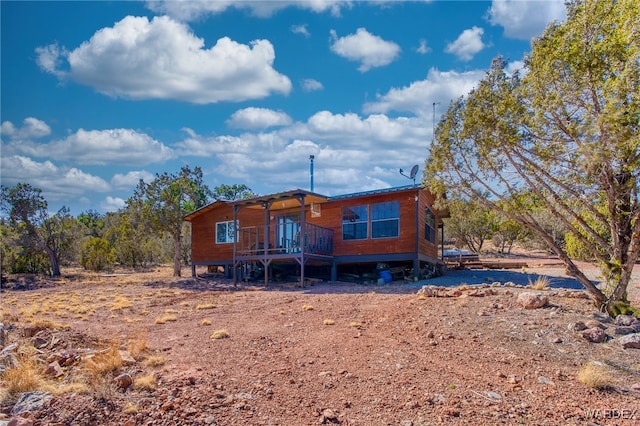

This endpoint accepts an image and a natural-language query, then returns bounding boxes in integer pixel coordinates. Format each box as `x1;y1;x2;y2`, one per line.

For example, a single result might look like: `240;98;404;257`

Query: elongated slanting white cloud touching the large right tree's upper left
363;68;486;119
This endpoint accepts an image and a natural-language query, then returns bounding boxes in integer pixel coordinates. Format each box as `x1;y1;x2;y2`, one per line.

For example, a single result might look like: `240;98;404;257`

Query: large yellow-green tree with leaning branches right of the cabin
425;0;640;315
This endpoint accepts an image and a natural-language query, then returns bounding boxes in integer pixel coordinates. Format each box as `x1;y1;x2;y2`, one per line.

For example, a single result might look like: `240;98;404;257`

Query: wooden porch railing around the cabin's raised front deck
237;222;333;256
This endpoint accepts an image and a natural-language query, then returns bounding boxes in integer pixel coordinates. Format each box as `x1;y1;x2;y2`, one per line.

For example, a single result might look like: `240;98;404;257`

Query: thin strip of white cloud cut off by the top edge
147;0;352;21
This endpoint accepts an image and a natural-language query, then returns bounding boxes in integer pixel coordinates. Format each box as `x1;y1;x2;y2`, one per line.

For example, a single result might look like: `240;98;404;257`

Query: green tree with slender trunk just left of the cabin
127;166;212;277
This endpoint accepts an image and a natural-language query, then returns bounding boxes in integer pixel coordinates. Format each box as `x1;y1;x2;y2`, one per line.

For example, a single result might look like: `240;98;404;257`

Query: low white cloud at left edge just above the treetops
2;155;110;201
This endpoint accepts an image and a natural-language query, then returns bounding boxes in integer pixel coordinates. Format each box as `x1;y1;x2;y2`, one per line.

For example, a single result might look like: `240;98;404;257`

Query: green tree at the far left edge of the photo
0;183;72;276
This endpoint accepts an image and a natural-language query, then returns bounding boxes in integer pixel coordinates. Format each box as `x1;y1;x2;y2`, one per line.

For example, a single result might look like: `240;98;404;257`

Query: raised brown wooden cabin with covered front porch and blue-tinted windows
185;186;443;285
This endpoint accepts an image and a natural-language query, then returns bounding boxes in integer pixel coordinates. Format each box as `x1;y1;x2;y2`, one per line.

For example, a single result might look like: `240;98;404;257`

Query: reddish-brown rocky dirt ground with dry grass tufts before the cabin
0;262;640;426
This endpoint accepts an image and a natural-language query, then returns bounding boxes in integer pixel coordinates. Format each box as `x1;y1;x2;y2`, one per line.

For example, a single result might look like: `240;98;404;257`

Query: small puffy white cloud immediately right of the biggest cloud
331;28;400;72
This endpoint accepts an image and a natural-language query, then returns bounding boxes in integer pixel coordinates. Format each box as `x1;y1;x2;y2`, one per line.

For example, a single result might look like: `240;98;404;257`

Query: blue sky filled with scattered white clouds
0;0;565;215
